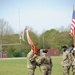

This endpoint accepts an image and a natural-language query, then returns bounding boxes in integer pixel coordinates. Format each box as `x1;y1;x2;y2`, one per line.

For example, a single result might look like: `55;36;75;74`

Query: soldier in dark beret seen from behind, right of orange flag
36;50;52;75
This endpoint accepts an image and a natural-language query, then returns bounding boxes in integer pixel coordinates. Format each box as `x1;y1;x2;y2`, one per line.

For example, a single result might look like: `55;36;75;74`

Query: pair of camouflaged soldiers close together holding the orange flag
27;49;53;75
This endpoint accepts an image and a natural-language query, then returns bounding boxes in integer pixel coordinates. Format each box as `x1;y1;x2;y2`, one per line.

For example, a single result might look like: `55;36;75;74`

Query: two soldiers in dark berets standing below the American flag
61;45;75;75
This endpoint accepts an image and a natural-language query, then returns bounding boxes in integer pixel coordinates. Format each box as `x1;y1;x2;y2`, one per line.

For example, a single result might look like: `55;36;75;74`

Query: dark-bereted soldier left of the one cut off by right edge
61;46;71;75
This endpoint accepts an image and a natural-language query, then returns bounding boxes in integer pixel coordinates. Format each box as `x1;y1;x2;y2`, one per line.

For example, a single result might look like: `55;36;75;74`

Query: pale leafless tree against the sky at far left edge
0;19;14;44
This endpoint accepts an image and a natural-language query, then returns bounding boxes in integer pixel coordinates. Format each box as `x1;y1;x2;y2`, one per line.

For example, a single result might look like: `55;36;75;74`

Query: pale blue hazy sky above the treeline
0;0;75;34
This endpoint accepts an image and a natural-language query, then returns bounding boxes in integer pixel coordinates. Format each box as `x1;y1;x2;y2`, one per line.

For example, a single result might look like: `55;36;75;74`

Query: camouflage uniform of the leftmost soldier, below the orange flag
27;51;36;75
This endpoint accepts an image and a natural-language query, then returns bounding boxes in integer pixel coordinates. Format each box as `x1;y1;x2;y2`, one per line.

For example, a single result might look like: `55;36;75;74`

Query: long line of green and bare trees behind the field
0;19;73;57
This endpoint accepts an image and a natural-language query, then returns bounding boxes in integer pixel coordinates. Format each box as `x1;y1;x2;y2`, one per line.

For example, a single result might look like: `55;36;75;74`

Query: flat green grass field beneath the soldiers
0;57;72;75
